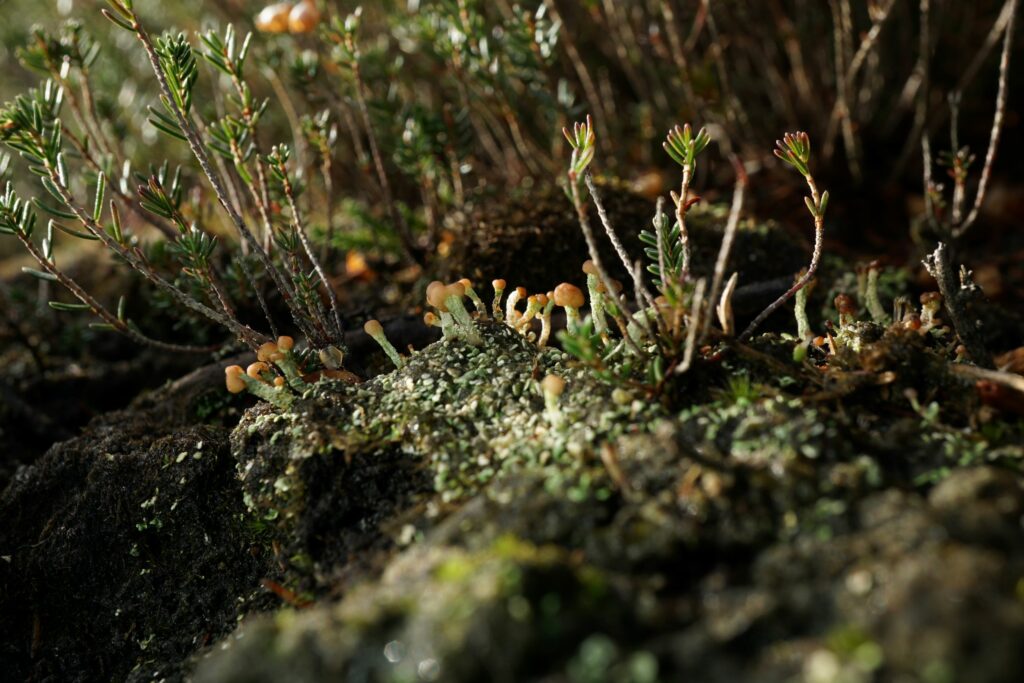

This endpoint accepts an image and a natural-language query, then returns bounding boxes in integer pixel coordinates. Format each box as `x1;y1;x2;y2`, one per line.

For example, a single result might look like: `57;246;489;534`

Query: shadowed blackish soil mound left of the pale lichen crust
0;369;271;681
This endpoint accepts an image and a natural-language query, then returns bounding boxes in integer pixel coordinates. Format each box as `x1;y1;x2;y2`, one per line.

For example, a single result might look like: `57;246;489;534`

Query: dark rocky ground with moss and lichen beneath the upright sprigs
0;194;1024;683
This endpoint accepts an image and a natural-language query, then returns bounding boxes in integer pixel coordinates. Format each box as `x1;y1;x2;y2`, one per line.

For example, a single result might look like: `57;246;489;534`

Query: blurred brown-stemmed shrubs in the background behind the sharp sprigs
0;0;1024;342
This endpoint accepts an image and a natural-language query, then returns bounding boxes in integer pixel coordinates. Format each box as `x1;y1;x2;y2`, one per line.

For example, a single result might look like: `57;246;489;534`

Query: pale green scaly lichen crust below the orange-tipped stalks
234;323;664;532
